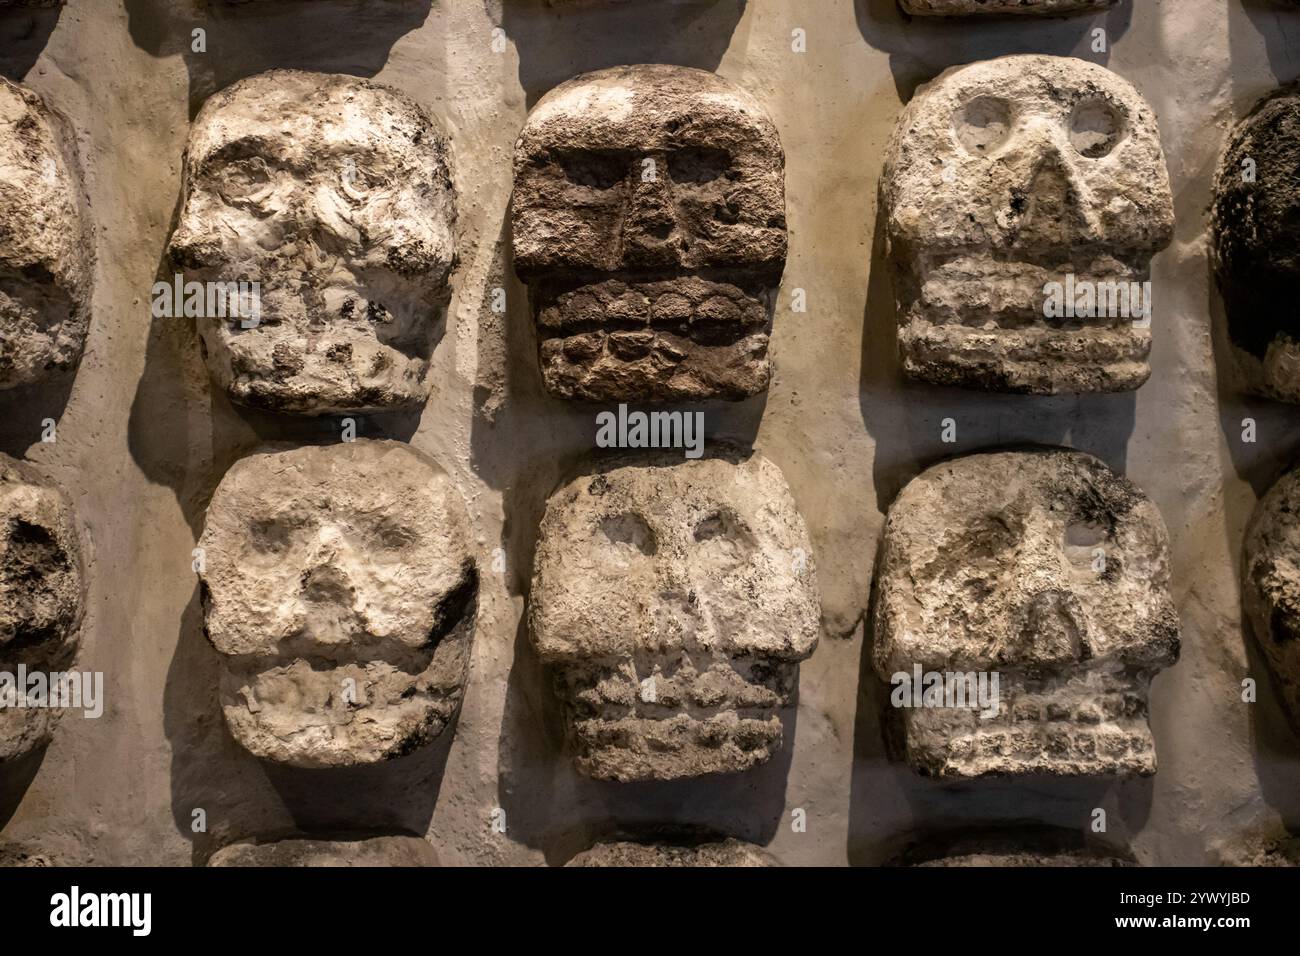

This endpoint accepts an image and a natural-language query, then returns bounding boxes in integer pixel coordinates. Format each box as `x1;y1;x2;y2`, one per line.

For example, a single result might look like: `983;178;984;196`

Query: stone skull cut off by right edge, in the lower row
1242;470;1300;734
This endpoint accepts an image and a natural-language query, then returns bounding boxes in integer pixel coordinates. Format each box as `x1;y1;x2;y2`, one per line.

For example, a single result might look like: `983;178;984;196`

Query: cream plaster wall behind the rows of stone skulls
0;0;1300;865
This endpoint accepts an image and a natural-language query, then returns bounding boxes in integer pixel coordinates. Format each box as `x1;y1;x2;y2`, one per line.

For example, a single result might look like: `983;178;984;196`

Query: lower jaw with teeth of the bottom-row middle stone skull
571;714;781;783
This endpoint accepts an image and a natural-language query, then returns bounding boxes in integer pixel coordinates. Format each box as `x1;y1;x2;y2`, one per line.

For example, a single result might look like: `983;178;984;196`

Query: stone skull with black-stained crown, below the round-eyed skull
874;449;1179;778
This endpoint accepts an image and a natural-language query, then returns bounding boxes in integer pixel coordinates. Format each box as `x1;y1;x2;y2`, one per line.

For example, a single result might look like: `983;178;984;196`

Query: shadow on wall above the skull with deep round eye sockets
854;0;1139;103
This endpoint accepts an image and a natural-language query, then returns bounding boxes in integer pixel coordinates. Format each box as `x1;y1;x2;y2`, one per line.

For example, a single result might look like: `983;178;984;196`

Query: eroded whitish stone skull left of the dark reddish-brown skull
169;70;455;415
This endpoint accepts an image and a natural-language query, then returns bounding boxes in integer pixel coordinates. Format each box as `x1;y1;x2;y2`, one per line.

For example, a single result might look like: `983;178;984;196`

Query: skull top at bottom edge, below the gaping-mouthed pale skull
208;834;438;866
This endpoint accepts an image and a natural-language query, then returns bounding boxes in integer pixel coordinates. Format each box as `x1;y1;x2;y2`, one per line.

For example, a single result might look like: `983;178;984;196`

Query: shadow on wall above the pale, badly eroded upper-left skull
125;0;433;118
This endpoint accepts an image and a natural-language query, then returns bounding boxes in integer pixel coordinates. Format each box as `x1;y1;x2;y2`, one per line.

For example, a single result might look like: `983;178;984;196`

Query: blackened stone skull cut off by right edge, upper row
1212;86;1300;402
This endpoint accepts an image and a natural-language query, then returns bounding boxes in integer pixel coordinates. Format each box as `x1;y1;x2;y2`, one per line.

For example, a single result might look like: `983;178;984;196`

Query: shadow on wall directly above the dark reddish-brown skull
485;0;745;108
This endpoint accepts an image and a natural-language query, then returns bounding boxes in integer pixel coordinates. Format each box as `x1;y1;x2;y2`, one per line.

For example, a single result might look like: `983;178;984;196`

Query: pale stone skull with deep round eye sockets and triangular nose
881;56;1174;394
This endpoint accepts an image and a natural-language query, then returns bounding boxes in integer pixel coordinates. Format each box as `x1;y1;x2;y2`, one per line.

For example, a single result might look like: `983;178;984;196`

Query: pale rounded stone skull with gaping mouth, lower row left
199;440;477;767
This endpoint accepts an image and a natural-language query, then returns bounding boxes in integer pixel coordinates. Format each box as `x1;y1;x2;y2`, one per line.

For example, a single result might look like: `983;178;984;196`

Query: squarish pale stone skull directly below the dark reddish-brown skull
529;449;820;782
